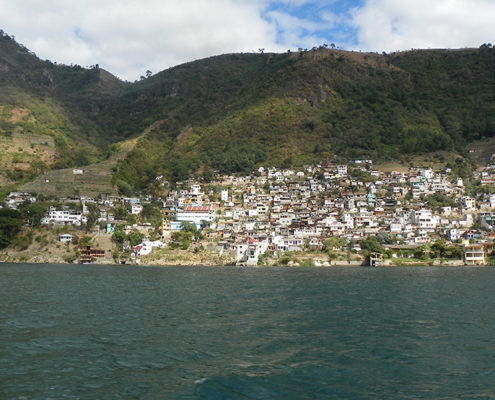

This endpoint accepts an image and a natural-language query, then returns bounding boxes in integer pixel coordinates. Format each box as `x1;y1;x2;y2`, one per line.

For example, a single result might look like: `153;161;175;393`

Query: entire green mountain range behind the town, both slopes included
0;29;495;194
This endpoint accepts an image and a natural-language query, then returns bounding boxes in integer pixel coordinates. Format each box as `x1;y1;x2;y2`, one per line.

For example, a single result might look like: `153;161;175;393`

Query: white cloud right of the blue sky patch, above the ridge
352;0;495;51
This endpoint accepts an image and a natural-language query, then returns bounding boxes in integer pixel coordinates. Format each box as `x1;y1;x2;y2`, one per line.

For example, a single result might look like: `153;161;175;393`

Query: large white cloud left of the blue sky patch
0;0;282;80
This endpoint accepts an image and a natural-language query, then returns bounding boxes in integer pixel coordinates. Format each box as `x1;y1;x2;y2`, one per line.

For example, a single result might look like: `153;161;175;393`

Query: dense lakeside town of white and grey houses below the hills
0;159;495;266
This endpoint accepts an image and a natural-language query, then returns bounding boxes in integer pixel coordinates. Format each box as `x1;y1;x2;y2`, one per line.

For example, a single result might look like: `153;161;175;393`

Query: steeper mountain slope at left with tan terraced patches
0;32;126;185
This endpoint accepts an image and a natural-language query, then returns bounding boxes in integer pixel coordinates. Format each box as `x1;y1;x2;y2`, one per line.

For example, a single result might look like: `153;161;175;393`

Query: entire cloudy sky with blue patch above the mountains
0;0;495;81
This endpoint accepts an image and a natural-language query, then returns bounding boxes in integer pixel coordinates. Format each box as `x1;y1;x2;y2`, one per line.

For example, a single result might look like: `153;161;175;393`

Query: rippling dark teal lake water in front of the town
0;264;495;400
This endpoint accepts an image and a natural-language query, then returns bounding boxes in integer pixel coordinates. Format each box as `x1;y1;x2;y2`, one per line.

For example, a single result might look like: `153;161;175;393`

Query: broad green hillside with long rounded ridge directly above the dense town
108;48;495;189
